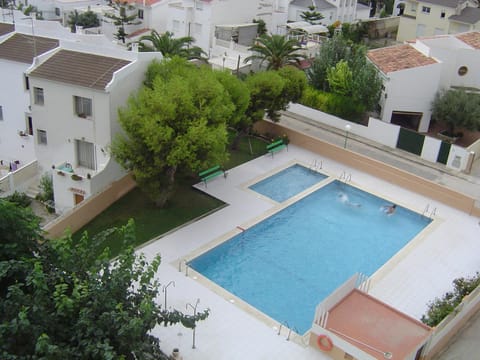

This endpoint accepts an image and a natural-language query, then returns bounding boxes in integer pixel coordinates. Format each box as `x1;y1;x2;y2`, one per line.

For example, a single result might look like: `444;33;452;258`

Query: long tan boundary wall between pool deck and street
255;121;480;216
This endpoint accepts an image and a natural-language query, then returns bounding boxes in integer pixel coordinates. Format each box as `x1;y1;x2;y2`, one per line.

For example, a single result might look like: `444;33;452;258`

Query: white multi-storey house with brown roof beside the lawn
28;42;159;213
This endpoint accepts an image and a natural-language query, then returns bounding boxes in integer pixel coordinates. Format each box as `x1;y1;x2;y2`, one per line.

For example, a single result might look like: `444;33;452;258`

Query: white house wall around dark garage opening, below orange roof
382;63;442;132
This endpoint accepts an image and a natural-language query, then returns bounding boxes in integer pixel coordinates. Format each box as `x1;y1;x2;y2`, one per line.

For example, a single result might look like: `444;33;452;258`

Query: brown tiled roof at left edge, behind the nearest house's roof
0;33;58;64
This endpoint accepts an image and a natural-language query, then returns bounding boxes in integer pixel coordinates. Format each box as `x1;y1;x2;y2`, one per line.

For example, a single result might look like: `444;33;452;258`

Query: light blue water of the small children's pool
250;164;327;202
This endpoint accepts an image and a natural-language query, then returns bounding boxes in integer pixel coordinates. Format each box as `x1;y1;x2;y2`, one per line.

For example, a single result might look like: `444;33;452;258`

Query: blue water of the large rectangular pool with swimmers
190;181;430;333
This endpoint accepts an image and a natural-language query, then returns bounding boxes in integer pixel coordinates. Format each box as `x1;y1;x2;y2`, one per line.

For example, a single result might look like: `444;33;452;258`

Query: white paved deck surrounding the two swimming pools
140;145;480;360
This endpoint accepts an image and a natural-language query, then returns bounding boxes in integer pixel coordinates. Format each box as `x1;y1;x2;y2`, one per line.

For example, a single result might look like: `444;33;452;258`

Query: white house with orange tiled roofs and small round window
367;32;480;132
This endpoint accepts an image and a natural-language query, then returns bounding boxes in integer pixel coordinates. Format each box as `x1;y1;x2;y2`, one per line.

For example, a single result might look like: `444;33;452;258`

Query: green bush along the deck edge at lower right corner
421;272;480;326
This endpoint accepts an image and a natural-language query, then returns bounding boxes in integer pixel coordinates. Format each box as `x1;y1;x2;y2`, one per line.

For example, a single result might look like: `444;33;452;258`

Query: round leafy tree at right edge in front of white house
432;89;480;136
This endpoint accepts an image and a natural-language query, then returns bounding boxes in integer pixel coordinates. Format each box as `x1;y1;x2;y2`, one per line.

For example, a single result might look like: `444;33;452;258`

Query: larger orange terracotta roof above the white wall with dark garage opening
367;44;437;74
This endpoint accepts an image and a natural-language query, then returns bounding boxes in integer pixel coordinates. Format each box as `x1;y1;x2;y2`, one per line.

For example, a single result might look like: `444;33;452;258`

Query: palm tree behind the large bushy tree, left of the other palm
138;30;206;60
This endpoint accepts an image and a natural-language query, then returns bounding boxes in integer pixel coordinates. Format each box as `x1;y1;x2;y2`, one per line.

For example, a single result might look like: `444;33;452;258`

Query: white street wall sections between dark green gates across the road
288;103;474;173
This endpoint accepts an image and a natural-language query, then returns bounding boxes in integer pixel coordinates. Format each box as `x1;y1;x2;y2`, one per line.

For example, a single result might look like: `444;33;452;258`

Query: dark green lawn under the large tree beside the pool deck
74;137;266;256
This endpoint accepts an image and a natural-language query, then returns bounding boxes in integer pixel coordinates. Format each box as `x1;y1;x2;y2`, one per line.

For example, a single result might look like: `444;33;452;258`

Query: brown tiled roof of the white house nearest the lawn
30;50;130;90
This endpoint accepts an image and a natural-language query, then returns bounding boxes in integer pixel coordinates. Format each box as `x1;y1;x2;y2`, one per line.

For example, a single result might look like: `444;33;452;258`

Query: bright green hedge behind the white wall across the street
300;87;365;122
